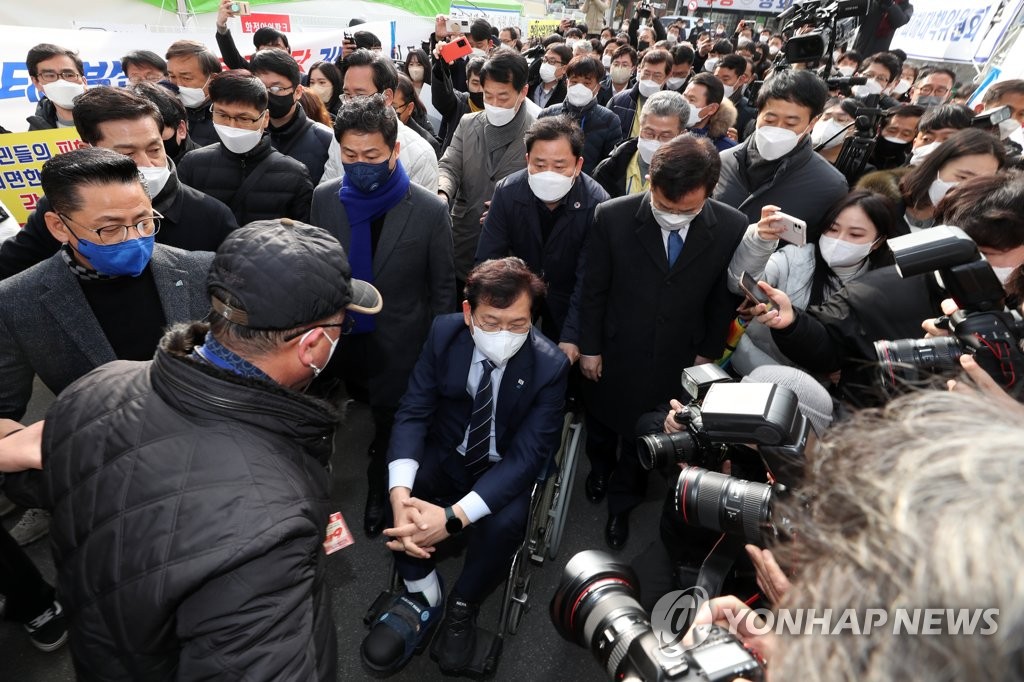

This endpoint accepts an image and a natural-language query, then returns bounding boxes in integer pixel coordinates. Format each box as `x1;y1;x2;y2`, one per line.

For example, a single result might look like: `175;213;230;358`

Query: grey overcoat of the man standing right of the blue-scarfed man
438;106;535;280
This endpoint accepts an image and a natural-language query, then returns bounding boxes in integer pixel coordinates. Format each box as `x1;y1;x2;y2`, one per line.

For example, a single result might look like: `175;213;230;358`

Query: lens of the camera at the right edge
874;336;963;391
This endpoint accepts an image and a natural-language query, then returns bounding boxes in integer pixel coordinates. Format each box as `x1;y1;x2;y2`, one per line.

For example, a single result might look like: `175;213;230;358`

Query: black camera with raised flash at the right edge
874;225;1024;399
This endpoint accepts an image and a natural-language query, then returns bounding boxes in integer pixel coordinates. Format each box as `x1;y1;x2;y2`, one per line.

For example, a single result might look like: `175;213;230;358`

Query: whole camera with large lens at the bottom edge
551;550;764;682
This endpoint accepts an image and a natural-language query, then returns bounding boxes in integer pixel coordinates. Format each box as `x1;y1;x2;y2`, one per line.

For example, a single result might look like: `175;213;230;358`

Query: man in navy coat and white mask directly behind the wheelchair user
476;117;608;363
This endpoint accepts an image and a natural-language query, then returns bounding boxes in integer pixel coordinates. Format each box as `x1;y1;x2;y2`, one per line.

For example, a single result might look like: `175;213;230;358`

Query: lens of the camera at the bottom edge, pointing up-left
551;550;650;679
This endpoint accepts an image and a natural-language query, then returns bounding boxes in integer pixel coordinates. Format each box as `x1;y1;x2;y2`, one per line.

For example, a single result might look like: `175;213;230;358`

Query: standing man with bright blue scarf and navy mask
310;95;456;538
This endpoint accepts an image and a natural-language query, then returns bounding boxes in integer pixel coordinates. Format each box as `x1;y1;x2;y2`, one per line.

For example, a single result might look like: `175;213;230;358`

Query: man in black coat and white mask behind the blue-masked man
0;86;238;280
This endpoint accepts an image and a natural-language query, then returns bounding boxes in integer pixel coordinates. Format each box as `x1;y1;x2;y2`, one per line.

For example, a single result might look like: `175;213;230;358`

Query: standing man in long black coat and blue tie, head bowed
580;135;746;549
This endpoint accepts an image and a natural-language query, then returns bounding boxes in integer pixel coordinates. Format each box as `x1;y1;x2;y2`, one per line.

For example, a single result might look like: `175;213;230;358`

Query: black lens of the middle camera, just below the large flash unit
676;467;774;547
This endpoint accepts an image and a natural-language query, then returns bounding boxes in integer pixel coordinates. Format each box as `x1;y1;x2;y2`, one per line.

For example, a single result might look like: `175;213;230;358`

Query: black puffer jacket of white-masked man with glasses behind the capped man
178;135;313;226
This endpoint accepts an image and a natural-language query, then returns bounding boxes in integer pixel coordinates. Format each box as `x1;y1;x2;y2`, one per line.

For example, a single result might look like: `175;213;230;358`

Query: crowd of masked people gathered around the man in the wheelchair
0;0;1024;680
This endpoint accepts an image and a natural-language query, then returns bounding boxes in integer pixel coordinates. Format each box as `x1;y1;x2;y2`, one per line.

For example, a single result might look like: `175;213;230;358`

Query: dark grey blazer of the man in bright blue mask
0;244;213;420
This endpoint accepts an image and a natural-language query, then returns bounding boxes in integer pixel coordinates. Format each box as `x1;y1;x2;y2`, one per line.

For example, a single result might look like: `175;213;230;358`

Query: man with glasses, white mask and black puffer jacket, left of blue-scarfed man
178;71;313;225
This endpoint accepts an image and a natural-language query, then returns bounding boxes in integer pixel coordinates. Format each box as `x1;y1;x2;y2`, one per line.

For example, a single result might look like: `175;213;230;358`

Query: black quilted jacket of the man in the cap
43;324;337;682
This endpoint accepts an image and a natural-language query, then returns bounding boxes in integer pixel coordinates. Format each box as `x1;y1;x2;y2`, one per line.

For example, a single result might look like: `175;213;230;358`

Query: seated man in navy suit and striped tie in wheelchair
361;258;569;674
